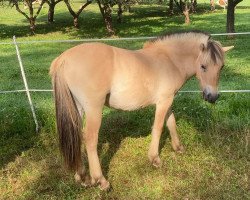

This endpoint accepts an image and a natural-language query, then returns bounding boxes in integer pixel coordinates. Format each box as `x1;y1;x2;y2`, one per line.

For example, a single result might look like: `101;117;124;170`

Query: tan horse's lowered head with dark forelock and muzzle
196;39;233;103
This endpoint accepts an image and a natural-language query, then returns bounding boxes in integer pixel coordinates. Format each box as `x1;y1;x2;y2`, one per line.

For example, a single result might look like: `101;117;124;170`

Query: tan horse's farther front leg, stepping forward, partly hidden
166;110;184;153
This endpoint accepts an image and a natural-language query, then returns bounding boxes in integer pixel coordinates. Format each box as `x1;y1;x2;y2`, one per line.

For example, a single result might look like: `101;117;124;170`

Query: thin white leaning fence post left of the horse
13;36;39;132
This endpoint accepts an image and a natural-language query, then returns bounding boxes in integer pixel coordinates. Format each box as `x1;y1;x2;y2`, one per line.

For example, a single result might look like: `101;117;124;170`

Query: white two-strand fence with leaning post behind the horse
0;32;250;132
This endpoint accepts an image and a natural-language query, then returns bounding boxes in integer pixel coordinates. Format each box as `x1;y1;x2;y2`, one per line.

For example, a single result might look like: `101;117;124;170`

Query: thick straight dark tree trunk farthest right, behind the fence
227;0;243;33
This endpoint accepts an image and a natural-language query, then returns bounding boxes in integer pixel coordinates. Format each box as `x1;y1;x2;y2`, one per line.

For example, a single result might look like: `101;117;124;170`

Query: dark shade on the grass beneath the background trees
0;6;247;39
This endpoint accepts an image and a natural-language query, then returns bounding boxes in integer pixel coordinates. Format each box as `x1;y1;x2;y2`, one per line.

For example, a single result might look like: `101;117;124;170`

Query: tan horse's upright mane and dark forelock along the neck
144;30;224;65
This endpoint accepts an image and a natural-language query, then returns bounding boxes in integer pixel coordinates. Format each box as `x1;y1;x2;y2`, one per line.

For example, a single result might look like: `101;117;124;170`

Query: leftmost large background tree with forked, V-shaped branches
10;0;45;34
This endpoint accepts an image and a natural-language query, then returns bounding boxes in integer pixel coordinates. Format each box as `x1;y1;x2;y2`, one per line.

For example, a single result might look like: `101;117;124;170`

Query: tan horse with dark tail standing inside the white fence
50;31;233;190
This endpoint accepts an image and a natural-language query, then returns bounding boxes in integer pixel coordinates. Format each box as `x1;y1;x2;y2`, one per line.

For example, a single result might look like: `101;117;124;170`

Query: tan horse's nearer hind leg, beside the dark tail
84;102;109;190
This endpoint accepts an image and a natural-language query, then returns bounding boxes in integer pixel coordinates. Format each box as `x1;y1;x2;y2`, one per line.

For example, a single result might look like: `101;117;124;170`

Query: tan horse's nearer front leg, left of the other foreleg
148;97;173;167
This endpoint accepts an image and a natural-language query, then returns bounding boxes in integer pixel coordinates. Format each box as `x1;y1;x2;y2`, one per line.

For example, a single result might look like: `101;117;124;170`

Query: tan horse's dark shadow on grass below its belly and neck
99;96;212;178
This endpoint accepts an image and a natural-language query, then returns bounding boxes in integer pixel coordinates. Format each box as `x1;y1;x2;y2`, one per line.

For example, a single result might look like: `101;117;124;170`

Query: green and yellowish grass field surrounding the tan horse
0;0;250;200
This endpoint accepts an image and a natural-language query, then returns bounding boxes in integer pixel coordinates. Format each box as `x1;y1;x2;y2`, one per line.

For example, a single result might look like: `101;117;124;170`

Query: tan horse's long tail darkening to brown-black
50;59;82;171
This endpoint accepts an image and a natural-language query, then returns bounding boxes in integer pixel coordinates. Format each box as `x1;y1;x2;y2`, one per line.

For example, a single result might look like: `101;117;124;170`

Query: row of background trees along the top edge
0;0;243;35
